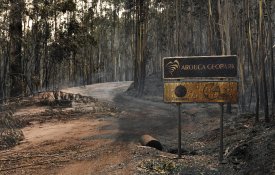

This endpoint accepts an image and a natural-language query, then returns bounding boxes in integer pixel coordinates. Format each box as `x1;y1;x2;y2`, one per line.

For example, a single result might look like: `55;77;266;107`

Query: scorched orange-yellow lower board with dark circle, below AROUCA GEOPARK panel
164;81;238;104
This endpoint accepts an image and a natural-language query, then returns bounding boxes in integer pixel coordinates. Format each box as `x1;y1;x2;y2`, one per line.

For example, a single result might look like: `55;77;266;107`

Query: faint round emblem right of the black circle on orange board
203;83;221;100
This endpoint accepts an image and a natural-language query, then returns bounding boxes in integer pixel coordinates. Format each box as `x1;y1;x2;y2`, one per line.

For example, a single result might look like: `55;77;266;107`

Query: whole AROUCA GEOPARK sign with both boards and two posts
163;55;238;162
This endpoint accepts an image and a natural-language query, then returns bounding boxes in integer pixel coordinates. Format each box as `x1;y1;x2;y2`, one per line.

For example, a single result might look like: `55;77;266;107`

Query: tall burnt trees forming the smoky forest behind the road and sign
0;0;275;122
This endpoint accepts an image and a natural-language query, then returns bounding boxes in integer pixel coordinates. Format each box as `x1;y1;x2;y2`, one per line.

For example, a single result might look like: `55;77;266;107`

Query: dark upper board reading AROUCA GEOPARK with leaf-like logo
163;55;238;79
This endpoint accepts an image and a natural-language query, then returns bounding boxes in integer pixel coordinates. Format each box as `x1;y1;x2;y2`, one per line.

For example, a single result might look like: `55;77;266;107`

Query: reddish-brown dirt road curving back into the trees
0;82;234;175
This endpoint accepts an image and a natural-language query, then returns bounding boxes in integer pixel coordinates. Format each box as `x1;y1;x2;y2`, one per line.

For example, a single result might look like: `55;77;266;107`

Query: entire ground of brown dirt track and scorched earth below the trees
0;76;275;175
